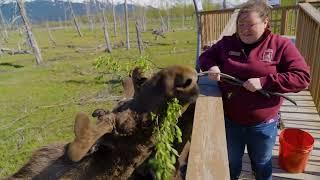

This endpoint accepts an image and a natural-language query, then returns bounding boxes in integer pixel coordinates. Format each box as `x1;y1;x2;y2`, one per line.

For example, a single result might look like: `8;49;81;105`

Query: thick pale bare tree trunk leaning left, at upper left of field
17;0;42;64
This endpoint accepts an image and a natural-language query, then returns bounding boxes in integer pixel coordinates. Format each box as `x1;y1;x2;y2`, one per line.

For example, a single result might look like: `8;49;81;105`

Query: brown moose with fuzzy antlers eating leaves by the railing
8;66;199;180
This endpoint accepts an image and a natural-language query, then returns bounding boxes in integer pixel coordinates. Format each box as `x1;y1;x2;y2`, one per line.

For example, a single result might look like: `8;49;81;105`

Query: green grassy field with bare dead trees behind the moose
0;18;196;178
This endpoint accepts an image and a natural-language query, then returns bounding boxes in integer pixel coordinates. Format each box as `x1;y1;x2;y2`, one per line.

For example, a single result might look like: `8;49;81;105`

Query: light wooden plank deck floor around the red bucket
240;91;320;180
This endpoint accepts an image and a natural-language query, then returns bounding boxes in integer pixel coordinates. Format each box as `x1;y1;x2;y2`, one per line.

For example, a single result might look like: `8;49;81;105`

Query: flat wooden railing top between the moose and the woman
186;77;230;180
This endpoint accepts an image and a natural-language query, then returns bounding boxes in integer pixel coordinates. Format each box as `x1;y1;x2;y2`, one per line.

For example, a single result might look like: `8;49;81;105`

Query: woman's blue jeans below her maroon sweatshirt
225;117;279;180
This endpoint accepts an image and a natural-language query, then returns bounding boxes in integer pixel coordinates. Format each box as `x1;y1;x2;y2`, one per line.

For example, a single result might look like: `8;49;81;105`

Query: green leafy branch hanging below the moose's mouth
149;98;182;180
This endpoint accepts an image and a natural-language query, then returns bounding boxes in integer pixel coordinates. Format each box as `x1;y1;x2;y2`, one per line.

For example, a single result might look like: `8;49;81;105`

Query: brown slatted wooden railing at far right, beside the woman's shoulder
296;3;320;112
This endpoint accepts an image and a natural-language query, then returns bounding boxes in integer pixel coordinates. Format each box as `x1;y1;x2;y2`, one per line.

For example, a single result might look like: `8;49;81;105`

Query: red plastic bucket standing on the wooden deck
279;128;314;173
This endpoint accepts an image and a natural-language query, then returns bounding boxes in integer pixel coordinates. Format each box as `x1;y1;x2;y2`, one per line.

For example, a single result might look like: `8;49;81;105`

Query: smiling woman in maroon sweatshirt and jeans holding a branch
199;1;310;180
